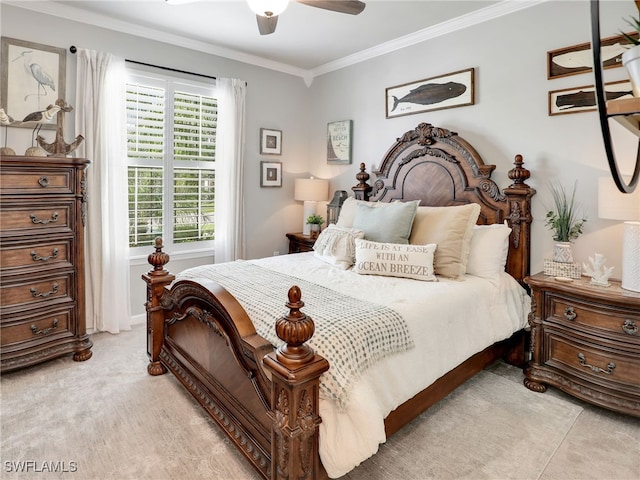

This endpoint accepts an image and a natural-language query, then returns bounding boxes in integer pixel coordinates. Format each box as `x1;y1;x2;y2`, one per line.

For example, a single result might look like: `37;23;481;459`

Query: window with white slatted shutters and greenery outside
126;72;217;254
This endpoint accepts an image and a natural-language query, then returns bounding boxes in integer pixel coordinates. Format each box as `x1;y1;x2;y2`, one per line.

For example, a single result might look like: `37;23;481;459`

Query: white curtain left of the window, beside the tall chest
75;49;131;333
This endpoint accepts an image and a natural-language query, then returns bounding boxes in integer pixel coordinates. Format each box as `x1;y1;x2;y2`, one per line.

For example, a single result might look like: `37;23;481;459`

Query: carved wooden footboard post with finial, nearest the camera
263;286;329;480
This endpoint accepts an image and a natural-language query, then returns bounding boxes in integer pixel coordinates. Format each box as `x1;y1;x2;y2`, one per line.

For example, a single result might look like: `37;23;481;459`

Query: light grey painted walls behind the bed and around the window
0;1;635;322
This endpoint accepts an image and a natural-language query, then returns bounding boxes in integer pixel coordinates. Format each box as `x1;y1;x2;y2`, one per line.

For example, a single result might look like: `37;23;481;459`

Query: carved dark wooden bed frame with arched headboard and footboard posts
143;123;535;479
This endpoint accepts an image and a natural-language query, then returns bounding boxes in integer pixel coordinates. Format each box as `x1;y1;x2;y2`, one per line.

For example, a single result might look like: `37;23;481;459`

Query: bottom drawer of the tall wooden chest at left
0;307;73;350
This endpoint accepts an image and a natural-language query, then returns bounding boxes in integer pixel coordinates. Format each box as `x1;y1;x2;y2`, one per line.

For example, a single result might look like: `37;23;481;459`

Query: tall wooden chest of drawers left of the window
0;156;92;371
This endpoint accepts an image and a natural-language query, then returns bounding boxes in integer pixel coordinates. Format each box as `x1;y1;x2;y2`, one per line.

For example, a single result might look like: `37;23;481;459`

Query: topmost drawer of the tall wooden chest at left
0;169;74;195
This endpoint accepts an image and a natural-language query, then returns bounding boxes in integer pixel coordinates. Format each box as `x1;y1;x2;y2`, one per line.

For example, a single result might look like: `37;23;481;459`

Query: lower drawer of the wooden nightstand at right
544;331;640;392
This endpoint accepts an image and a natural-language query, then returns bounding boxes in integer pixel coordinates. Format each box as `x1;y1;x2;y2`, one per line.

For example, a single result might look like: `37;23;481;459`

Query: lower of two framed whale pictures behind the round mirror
549;80;633;116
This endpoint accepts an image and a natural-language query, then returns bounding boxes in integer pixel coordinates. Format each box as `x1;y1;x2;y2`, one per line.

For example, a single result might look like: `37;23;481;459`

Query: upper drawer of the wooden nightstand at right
546;295;640;345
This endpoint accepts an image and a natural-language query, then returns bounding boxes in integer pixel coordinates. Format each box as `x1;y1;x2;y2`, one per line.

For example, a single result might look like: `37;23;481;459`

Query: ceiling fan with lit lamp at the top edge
165;0;366;35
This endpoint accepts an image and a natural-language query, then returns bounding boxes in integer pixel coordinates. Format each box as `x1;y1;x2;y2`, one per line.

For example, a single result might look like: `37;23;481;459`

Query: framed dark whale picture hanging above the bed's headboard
385;68;474;118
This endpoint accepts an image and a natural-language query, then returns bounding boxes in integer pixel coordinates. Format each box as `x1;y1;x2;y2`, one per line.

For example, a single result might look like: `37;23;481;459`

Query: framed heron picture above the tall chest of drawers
1;37;67;129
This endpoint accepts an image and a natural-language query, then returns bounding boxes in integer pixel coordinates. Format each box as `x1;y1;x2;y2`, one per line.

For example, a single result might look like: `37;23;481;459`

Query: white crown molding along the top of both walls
2;0;550;86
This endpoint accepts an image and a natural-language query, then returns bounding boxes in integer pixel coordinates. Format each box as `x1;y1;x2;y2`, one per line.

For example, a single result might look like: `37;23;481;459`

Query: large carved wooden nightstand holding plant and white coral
524;273;640;416
